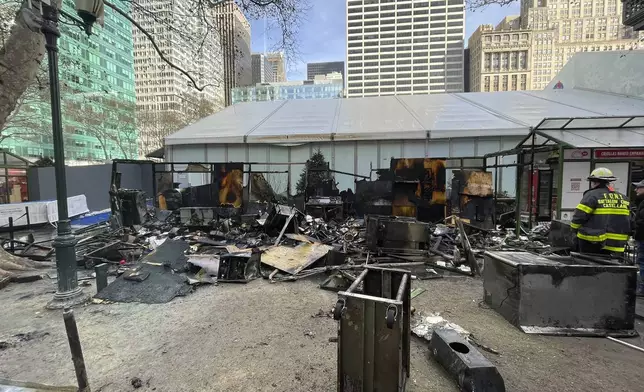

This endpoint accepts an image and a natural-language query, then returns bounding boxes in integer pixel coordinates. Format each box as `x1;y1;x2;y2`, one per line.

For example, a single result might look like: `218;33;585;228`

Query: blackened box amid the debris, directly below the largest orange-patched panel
367;216;429;251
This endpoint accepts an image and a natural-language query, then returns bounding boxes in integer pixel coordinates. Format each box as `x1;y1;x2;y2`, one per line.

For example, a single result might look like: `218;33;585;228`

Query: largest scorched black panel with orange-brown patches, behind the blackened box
391;158;446;221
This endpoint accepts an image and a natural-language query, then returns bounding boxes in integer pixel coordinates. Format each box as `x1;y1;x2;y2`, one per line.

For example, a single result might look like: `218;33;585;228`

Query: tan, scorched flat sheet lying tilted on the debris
262;243;333;275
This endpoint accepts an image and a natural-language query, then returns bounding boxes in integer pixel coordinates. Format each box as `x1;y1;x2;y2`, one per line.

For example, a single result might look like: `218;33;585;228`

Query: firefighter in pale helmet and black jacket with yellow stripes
570;167;631;255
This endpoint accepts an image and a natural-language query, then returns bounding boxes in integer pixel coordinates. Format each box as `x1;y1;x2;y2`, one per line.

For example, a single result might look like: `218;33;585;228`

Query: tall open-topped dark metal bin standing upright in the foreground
333;267;411;392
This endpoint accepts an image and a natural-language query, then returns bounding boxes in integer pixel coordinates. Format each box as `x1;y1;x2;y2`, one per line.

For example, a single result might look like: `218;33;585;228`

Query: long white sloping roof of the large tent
166;89;644;145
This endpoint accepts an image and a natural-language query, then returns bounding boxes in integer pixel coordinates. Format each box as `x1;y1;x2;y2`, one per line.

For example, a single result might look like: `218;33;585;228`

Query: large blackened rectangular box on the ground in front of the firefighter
483;252;637;336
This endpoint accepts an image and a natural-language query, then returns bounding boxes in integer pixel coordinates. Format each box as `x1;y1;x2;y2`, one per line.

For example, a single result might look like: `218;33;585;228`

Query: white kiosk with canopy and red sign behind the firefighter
485;116;644;234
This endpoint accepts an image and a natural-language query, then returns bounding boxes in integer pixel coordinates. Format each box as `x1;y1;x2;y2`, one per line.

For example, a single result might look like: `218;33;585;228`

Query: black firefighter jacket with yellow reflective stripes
570;186;631;253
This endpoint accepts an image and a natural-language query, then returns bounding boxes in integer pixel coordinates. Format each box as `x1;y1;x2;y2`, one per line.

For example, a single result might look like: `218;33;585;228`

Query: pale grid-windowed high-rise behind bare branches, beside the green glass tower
133;0;224;153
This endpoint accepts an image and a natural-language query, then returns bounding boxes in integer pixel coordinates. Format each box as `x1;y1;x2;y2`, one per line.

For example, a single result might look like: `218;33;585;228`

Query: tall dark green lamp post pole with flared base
41;3;89;309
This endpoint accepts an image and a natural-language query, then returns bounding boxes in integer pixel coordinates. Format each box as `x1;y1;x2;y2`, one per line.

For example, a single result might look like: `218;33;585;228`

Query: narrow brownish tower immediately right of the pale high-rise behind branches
213;0;253;106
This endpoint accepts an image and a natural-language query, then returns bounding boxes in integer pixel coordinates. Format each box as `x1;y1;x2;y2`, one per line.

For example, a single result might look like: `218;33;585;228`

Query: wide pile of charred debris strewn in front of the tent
77;198;548;303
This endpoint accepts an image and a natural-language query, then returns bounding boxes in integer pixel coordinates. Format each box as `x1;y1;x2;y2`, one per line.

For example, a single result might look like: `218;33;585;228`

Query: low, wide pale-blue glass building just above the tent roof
232;72;344;104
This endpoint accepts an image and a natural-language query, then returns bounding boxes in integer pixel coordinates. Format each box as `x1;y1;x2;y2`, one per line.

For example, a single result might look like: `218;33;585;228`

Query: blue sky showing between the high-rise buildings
251;0;519;80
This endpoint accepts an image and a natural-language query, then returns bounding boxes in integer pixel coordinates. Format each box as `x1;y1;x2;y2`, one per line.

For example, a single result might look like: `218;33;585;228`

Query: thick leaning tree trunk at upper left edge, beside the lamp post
0;5;45;129
